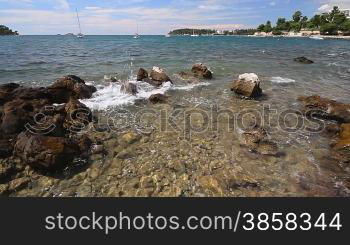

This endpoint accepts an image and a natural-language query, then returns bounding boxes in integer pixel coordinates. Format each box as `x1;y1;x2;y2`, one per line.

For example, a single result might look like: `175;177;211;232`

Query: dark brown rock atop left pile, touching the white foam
48;75;97;104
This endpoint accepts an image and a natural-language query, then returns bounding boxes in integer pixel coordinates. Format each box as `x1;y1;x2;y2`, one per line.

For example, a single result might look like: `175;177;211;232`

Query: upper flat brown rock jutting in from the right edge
298;95;350;123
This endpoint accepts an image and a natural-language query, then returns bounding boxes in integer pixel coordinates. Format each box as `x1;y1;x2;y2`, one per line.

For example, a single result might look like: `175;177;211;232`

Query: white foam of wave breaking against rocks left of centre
81;77;209;110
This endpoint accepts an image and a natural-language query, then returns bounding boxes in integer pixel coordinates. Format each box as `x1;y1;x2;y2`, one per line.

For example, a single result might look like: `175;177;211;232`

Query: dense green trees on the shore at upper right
257;6;350;35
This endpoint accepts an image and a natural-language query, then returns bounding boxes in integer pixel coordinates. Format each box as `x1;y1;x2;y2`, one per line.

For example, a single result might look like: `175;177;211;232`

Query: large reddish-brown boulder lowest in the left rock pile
14;132;81;170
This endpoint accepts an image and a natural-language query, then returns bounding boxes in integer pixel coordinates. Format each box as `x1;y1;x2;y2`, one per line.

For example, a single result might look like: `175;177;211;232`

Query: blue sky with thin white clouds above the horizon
0;0;350;35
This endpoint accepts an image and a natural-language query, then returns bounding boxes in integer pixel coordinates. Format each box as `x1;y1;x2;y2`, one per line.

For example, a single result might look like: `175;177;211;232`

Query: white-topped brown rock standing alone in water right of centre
231;73;262;98
